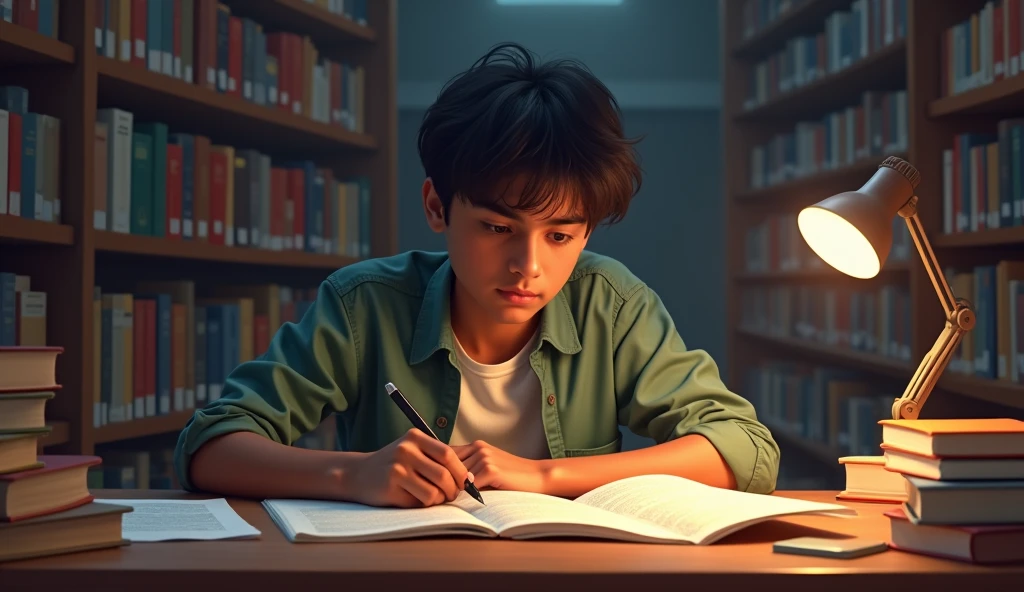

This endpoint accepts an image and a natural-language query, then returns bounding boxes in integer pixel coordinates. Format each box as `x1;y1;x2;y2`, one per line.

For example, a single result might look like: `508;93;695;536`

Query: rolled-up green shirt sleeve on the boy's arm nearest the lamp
614;286;779;494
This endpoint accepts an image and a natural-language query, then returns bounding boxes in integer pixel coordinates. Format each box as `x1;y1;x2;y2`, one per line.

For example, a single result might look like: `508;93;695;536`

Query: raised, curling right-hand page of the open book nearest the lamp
573;475;856;545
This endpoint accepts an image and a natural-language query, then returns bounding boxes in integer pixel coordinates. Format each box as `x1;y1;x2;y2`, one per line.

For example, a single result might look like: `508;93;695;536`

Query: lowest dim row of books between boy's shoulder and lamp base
743;361;900;455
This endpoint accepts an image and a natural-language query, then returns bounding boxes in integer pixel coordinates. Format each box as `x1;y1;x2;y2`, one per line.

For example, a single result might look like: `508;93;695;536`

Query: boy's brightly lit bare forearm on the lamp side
540;434;736;498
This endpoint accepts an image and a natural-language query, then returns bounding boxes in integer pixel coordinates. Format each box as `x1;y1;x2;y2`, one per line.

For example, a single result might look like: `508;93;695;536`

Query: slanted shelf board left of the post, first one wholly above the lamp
734;39;906;121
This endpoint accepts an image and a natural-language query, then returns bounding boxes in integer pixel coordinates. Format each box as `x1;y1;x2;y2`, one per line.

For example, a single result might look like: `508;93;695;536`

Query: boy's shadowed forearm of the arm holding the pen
188;431;362;500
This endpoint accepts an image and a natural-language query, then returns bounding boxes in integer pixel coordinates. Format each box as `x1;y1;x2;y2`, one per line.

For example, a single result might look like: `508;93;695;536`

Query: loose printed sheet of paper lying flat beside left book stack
95;498;260;543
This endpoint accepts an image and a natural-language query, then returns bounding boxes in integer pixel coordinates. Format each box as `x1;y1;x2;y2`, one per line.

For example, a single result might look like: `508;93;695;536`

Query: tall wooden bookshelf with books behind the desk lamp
720;0;1024;487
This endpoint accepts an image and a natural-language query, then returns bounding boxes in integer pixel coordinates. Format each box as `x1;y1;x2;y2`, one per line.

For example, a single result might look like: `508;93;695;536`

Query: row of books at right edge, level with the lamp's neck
942;118;1024;235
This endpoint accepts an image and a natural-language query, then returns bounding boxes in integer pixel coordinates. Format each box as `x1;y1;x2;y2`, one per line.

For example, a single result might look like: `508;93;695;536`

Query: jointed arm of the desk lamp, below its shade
892;204;975;419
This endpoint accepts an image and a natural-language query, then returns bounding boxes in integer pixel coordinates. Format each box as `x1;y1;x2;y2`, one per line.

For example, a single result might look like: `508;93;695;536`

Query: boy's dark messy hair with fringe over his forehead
419;43;642;234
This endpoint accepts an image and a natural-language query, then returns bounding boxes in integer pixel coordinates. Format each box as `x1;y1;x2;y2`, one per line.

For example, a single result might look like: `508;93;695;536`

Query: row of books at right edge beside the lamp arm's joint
944;260;1024;384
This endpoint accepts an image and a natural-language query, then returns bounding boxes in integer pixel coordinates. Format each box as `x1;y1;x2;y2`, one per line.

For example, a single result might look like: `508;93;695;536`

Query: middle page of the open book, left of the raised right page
451;491;683;542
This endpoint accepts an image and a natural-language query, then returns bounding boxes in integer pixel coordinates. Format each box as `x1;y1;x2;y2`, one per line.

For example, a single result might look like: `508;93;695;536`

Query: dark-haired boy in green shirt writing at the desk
175;44;779;507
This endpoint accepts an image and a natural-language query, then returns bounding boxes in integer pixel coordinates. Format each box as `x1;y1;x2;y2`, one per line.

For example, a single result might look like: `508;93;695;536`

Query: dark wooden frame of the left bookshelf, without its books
0;0;397;479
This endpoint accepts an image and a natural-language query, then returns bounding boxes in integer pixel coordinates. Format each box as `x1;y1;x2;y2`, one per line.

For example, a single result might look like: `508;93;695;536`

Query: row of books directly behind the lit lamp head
743;210;913;273
